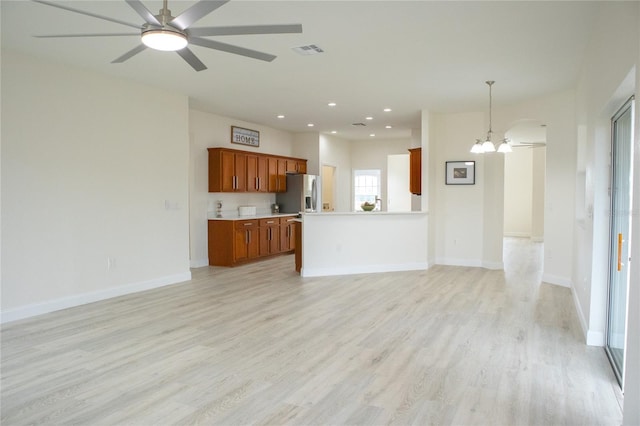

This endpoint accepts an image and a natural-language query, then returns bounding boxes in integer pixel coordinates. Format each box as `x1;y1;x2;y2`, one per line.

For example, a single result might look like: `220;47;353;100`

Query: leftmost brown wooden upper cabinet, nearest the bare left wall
208;148;247;192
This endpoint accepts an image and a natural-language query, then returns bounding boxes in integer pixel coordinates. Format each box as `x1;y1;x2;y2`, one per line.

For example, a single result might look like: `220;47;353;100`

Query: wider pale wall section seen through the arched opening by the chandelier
504;148;533;237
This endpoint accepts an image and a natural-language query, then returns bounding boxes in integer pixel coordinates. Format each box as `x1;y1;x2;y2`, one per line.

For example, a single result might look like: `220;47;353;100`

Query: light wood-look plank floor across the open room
1;239;622;425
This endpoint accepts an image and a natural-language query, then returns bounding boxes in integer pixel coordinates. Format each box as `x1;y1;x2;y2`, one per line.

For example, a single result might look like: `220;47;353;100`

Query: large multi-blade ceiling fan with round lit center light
33;0;302;71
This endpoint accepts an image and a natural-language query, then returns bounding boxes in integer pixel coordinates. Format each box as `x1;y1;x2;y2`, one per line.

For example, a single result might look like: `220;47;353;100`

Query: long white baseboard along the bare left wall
0;271;191;323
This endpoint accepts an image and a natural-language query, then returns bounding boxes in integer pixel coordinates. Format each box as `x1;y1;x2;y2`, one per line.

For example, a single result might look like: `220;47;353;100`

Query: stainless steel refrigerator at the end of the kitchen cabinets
276;175;322;213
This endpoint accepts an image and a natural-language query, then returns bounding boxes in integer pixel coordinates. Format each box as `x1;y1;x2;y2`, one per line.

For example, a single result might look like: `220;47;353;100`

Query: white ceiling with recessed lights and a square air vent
0;0;606;139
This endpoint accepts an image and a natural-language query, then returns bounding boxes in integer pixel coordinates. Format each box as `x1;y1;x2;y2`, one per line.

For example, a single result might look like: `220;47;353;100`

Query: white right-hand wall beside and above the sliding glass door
573;3;640;345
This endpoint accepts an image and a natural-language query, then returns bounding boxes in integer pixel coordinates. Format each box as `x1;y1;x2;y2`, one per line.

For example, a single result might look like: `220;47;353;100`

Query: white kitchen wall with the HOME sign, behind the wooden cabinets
189;109;296;267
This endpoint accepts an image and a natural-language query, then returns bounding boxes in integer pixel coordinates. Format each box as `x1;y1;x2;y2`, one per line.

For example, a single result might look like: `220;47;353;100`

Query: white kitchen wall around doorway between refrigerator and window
319;135;352;212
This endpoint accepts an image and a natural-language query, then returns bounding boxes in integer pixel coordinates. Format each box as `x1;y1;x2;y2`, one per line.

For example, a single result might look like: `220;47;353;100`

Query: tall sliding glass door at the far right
606;98;634;386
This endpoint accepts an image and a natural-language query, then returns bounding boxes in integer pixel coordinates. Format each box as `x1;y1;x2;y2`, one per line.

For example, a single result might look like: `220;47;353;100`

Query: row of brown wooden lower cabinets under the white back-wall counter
208;216;295;266
